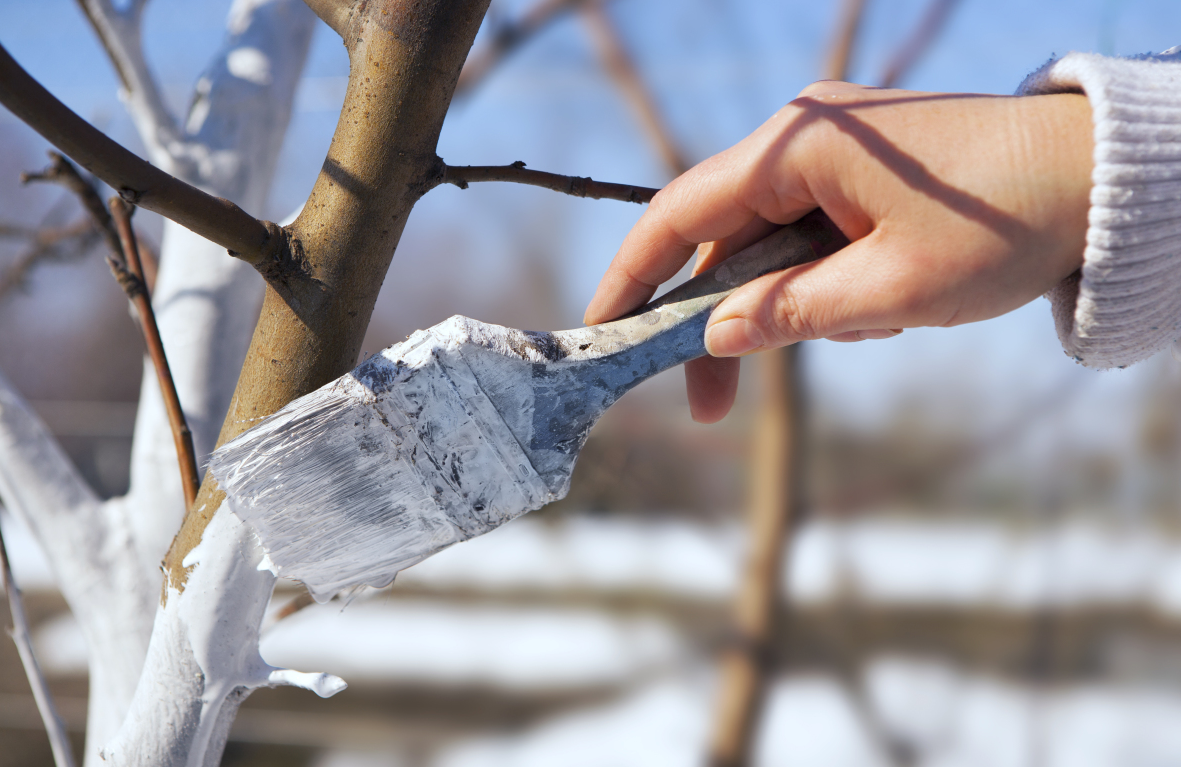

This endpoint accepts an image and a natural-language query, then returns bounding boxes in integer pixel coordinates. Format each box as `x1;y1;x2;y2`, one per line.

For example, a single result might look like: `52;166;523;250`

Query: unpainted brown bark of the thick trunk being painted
165;0;488;589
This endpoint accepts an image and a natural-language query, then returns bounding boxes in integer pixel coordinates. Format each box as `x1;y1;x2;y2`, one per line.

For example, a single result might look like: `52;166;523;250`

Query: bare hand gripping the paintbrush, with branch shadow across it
585;82;1094;423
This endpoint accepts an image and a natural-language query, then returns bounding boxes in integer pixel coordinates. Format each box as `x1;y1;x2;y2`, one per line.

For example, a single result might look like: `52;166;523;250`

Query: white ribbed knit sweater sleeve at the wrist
1017;46;1181;368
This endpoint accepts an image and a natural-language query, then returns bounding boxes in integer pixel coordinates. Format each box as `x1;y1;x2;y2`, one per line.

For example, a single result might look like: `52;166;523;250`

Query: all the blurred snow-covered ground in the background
13;503;1181;767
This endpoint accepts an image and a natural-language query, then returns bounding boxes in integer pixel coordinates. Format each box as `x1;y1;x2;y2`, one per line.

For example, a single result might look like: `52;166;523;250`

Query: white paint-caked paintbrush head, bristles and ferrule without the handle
210;324;554;600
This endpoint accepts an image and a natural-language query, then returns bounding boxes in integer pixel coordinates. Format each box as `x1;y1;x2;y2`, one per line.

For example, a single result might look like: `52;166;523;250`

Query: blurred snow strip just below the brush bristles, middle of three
262;600;684;689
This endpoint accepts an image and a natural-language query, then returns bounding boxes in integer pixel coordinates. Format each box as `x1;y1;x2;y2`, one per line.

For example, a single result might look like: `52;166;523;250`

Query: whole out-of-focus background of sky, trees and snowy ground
0;0;1181;767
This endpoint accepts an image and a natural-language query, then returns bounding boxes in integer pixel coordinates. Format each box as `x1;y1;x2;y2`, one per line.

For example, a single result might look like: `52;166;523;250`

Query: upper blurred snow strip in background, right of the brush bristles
398;514;1181;615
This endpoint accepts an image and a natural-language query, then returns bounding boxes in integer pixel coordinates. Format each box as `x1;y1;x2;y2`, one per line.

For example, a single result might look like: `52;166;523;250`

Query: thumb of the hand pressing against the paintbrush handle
705;229;955;357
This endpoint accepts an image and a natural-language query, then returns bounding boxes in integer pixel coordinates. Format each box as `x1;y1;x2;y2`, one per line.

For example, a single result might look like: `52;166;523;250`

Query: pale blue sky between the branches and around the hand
0;0;1181;451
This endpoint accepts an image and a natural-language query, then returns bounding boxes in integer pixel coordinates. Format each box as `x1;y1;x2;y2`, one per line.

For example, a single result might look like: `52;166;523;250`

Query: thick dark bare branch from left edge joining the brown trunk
0;46;275;267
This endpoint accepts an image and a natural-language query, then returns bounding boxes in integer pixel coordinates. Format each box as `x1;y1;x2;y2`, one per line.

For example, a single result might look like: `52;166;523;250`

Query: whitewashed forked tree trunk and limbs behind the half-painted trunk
0;0;315;765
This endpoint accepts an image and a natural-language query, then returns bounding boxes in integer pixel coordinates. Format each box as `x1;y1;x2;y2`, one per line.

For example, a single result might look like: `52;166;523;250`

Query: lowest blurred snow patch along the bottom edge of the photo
433;658;1181;767
